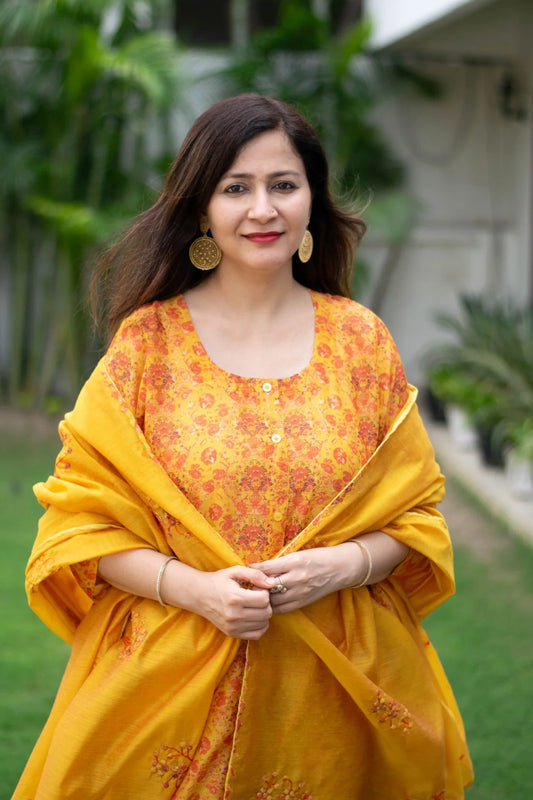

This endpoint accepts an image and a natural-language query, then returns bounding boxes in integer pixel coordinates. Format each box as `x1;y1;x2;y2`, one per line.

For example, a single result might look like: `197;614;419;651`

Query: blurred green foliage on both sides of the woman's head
0;0;414;408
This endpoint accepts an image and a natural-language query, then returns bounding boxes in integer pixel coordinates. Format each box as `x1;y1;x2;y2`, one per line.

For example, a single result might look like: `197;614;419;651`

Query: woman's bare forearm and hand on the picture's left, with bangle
98;548;276;639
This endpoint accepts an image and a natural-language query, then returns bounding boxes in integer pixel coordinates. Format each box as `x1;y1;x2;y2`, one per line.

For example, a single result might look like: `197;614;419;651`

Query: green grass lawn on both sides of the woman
0;434;533;800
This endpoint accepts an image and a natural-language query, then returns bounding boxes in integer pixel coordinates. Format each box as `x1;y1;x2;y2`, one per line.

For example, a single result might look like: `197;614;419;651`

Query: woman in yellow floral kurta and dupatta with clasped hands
15;95;471;800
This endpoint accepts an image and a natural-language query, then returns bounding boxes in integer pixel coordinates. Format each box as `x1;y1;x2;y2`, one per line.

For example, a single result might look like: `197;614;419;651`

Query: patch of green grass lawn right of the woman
426;522;533;800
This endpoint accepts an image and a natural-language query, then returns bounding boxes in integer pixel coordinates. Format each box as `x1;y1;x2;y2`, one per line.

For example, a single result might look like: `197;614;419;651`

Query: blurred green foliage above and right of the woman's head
220;0;416;302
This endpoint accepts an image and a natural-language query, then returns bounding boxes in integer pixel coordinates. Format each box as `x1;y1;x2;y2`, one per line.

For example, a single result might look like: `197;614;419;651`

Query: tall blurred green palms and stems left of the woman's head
0;0;180;407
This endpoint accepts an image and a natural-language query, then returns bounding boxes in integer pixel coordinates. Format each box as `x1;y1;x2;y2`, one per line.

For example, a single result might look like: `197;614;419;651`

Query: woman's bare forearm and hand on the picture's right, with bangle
252;531;409;614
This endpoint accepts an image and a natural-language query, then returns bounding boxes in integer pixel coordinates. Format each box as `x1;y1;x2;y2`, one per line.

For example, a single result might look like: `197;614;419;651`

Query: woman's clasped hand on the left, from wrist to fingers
189;566;276;639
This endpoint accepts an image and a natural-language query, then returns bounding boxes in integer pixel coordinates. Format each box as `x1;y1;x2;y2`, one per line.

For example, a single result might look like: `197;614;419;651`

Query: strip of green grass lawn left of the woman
0;433;69;800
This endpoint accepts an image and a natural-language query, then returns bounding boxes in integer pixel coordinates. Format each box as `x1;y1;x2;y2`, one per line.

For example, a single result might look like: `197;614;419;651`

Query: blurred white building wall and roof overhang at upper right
363;0;533;382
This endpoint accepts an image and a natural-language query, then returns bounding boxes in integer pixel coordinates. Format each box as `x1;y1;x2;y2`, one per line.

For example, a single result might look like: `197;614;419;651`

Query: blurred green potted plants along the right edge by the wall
427;296;533;500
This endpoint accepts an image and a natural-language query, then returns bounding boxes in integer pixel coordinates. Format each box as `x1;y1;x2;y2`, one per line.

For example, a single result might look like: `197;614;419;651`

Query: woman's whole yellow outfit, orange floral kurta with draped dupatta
14;294;471;800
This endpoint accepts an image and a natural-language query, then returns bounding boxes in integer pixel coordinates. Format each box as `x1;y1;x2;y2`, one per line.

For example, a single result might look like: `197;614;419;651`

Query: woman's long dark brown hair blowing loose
91;94;365;334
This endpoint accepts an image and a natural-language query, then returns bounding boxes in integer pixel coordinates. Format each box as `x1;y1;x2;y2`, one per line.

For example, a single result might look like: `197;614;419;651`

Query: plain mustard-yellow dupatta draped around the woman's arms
14;362;471;800
